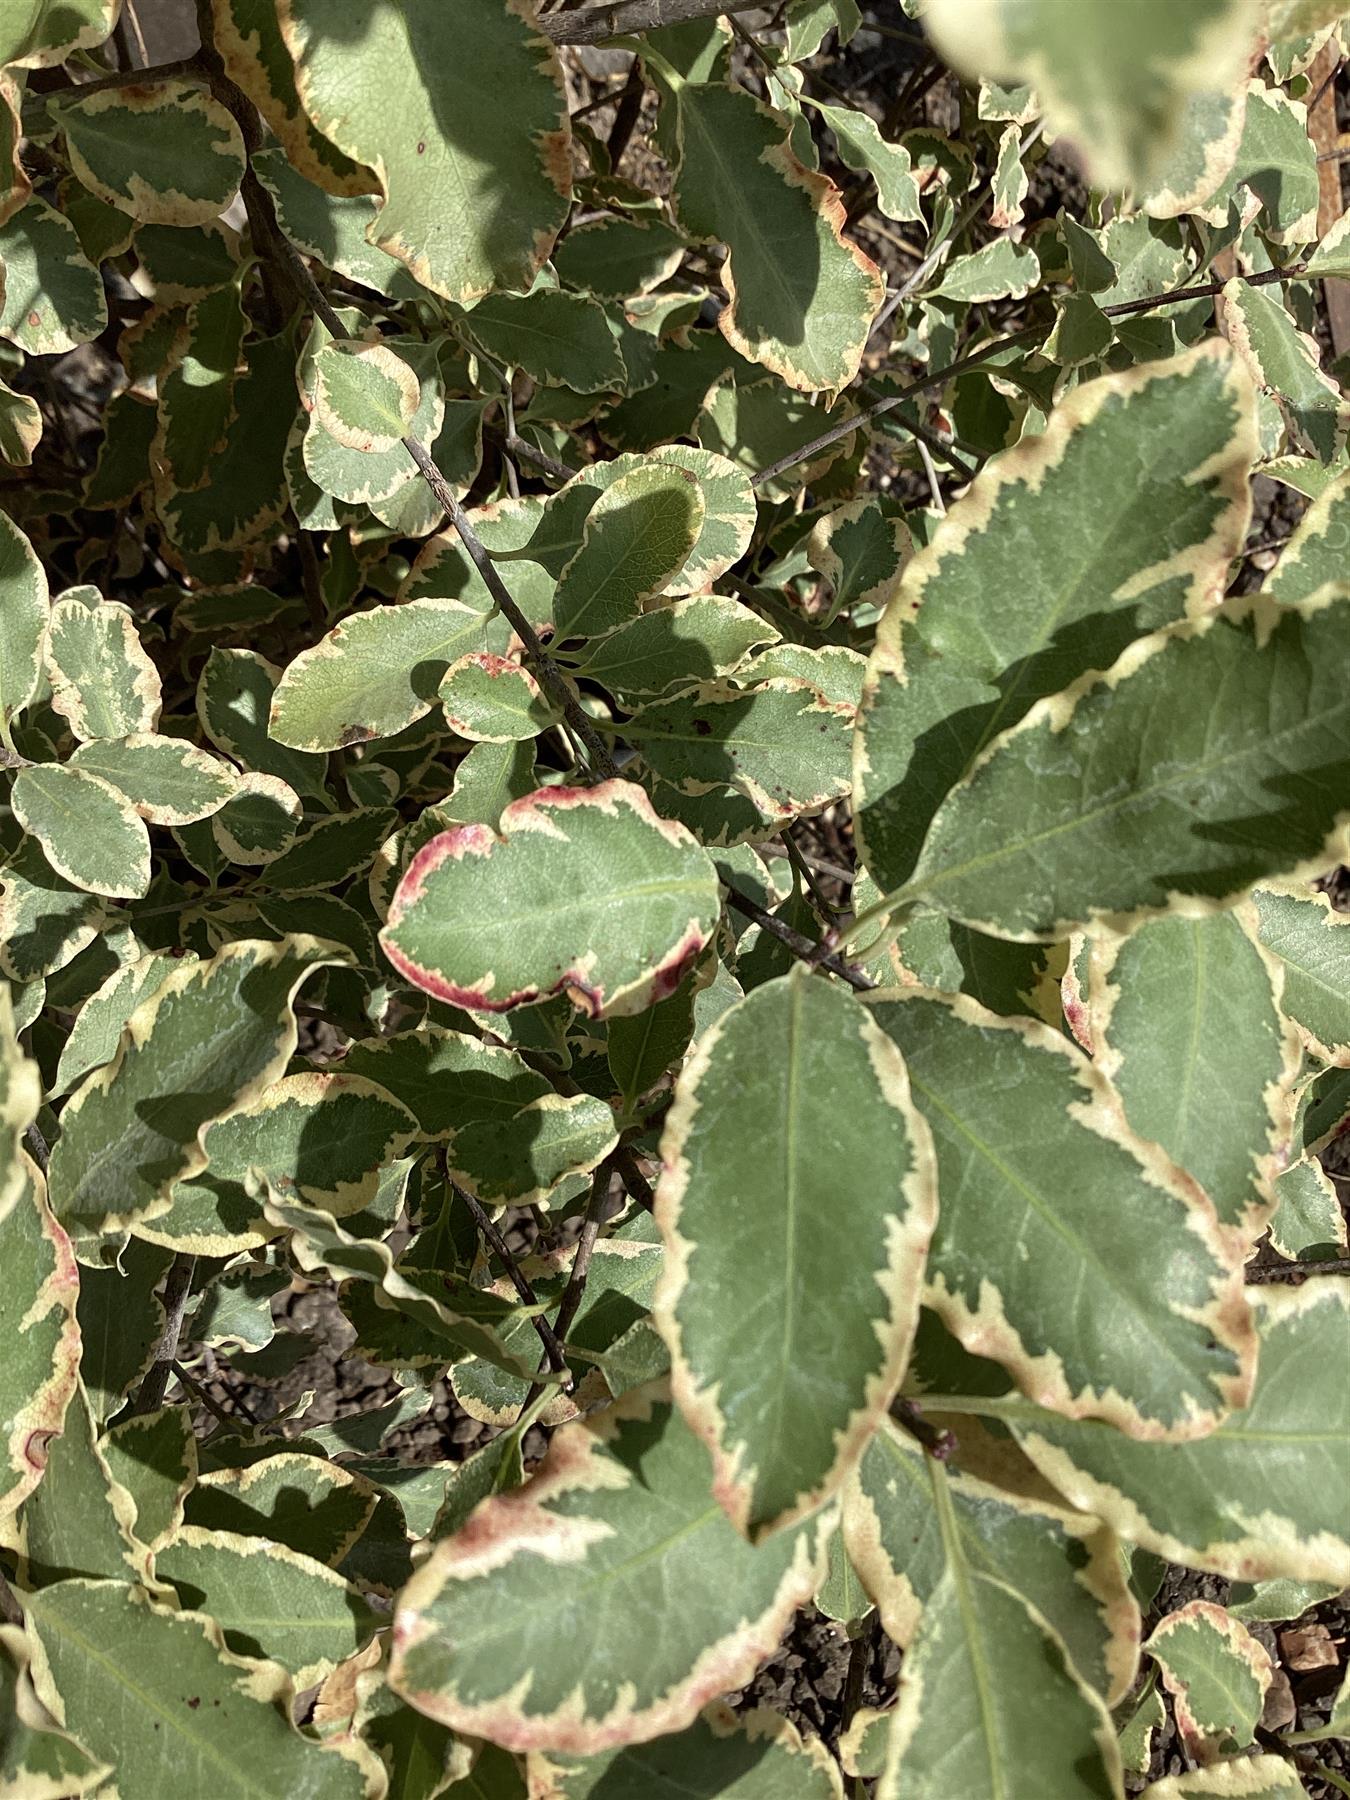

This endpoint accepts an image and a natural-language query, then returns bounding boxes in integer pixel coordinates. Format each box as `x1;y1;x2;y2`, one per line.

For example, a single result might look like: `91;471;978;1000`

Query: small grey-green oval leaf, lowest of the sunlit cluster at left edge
11;763;149;900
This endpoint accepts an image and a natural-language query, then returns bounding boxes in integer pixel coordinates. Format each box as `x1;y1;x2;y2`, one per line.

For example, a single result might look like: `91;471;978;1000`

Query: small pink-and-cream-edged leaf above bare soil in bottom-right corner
1145;1600;1274;1764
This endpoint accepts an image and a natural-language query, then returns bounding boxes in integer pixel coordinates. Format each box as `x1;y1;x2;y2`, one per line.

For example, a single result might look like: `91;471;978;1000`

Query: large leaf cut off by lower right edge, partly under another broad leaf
1015;1276;1350;1584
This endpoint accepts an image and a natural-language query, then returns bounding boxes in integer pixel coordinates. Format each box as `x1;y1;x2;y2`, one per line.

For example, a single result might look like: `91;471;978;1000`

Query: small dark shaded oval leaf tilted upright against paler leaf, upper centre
553;463;706;637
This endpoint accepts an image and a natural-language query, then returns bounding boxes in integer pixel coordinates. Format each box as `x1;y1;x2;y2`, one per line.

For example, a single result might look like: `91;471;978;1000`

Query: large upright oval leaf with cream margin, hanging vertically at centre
655;967;938;1539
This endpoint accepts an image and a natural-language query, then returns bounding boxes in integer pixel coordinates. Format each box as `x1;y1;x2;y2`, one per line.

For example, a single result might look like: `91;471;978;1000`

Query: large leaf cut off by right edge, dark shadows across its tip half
900;590;1350;940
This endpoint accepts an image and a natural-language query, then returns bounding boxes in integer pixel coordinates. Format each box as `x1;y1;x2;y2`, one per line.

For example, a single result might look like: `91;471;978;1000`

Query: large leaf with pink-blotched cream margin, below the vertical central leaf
389;1386;833;1755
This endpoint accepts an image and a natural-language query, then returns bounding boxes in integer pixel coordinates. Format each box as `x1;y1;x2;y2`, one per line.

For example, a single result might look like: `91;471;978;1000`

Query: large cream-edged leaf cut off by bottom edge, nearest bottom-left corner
27;1580;380;1800
